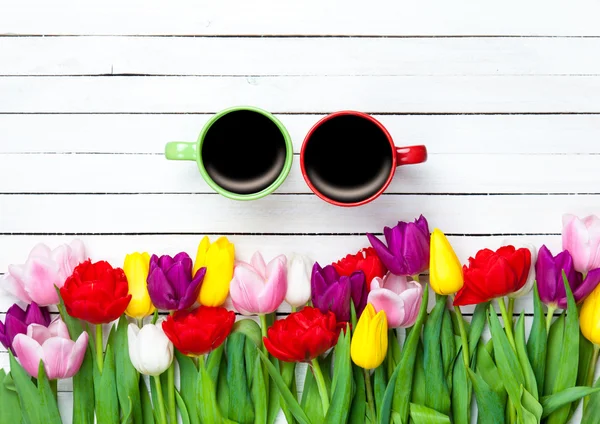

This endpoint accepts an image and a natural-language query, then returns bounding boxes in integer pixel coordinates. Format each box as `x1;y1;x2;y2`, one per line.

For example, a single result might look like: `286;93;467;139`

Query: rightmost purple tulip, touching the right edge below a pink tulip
535;245;600;309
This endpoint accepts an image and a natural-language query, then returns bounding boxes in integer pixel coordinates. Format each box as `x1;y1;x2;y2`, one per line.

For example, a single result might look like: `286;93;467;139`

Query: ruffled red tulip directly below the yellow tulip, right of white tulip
163;306;235;356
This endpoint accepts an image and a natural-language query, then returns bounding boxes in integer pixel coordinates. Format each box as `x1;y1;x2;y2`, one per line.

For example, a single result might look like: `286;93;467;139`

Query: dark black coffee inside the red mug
304;115;394;203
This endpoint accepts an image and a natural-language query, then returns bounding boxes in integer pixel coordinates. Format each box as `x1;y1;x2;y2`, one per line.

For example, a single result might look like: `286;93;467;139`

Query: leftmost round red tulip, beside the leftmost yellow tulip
60;259;131;324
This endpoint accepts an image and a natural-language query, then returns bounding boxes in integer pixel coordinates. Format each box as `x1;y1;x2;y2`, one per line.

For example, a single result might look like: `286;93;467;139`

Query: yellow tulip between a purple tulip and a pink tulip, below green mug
194;236;235;306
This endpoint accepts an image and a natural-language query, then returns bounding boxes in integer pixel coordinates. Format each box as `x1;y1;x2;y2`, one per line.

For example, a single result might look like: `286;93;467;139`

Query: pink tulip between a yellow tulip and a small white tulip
229;252;287;315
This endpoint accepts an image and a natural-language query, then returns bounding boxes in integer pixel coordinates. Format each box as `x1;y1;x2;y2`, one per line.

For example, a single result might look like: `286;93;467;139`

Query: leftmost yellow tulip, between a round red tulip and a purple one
123;252;154;319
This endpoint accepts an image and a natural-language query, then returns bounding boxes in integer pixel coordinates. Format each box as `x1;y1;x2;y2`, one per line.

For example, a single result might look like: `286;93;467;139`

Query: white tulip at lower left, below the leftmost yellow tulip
127;322;173;376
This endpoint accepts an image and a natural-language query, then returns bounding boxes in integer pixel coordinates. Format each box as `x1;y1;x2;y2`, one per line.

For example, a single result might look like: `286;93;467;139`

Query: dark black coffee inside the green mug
202;110;286;194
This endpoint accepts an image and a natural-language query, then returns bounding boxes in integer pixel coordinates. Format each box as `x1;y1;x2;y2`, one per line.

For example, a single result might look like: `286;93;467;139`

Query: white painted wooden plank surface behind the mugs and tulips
0;0;600;423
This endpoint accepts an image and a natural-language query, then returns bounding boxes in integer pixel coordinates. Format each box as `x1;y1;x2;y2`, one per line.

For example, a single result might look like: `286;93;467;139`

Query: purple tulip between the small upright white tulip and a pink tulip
310;262;368;322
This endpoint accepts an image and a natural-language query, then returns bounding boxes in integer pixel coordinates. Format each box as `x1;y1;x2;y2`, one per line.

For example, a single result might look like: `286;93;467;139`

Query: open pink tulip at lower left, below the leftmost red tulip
13;318;88;380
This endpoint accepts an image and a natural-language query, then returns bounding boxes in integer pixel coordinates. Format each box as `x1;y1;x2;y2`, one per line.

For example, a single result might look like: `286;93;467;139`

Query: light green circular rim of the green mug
196;106;294;200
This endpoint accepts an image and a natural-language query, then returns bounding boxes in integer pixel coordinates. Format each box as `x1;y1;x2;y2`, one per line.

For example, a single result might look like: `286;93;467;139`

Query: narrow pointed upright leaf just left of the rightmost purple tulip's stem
527;284;548;393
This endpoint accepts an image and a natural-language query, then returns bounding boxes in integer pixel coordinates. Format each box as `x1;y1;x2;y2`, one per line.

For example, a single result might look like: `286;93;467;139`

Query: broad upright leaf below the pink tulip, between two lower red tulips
226;332;254;424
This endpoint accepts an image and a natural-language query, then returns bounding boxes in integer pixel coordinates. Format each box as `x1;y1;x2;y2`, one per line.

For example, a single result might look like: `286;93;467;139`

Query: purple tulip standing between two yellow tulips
148;252;206;311
